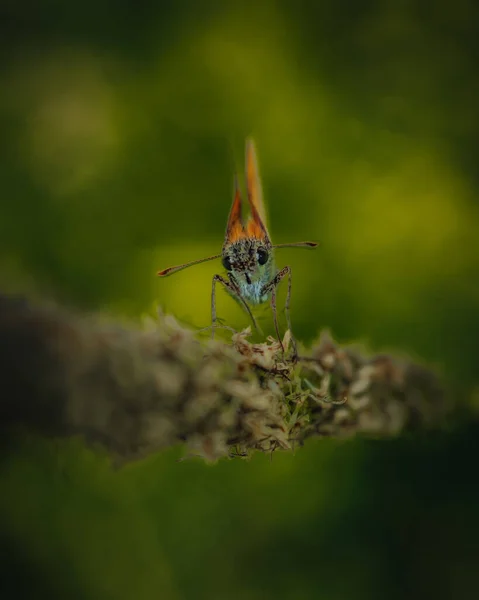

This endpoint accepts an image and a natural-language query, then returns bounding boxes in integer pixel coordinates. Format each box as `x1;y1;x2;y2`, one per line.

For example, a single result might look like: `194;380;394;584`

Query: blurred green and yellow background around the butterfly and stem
0;0;479;600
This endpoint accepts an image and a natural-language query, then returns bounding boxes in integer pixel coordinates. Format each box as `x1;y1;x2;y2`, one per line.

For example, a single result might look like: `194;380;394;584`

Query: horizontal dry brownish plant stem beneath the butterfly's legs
0;296;449;461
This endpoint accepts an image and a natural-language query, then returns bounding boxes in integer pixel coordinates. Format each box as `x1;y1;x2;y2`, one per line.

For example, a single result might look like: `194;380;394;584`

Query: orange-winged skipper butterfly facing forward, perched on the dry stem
158;139;318;350
